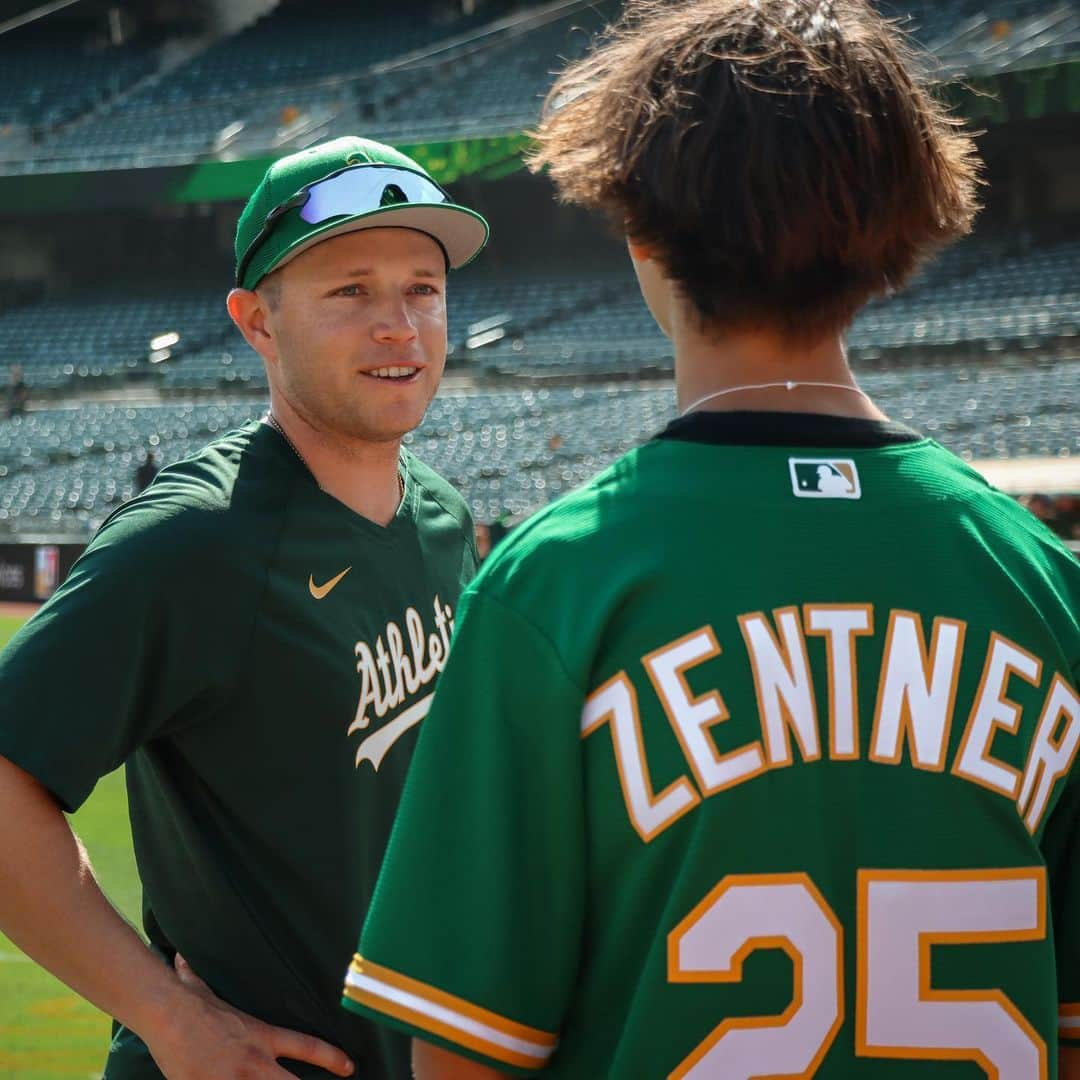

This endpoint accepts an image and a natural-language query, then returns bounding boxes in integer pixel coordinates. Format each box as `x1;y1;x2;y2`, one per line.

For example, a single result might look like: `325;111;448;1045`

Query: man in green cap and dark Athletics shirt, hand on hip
0;138;487;1080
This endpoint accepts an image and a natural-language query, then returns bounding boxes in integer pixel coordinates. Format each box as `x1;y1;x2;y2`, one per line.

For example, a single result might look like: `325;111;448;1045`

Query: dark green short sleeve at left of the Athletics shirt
0;504;243;811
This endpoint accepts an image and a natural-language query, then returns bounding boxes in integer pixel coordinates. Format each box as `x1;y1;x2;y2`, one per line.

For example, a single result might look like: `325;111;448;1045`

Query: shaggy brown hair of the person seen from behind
530;0;978;340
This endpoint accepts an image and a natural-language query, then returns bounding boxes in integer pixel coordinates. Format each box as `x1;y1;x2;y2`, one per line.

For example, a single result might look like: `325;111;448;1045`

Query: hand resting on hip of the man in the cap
147;955;353;1080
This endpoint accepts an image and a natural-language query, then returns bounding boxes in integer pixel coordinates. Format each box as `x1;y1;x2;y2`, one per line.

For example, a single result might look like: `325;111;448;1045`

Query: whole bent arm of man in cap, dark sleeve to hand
0;516;348;1080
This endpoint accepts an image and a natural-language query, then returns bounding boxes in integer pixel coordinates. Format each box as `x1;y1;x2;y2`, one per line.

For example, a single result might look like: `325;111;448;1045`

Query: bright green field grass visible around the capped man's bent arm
0;617;139;1080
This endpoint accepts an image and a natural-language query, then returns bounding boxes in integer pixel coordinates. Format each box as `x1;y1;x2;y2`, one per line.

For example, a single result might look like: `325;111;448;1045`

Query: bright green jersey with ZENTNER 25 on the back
343;414;1080;1080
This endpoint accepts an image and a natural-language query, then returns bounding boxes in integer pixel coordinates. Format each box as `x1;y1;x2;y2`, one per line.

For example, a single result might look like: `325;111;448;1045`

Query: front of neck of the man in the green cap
270;391;402;525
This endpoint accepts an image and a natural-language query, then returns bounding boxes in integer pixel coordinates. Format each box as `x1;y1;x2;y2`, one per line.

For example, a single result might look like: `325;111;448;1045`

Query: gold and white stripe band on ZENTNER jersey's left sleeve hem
345;956;558;1069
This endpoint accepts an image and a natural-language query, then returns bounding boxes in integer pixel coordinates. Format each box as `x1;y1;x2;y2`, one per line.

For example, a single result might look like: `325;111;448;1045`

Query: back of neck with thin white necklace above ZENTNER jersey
672;318;887;420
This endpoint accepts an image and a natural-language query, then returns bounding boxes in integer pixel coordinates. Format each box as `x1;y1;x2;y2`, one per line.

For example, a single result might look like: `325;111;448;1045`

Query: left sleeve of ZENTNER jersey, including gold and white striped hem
342;592;584;1075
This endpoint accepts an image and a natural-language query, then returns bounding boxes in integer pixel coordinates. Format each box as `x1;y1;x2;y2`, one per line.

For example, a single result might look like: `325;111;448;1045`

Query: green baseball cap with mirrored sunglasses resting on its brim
234;135;489;288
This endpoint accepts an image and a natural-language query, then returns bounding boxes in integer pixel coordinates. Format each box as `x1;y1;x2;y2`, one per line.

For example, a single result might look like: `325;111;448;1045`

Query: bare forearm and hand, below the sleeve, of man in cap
0;757;352;1080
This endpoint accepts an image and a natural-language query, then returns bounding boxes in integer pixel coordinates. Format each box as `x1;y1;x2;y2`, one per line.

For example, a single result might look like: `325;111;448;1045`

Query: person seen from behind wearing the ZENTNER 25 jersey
343;0;1080;1080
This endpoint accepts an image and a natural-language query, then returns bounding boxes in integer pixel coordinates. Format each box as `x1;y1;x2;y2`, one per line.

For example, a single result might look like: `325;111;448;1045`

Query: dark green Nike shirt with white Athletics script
0;423;475;1080
